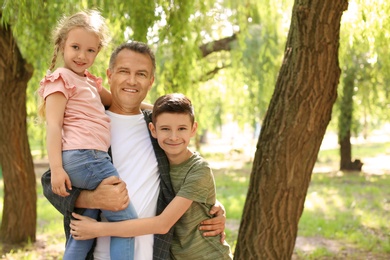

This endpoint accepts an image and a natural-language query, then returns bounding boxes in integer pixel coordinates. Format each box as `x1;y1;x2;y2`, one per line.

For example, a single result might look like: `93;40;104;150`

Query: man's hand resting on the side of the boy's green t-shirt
199;200;226;243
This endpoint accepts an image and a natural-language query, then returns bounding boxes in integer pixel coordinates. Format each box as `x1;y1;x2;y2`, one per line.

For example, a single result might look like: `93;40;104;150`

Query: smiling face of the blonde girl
63;28;100;76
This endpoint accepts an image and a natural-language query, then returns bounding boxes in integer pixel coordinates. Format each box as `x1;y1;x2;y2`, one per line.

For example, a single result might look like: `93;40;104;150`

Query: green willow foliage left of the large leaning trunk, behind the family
2;0;291;156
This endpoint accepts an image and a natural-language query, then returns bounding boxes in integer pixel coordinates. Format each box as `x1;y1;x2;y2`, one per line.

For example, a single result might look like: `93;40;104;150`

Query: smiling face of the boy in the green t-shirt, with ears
149;113;198;164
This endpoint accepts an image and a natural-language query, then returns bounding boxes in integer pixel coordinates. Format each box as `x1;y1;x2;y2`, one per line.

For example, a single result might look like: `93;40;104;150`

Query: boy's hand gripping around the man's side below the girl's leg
69;213;99;240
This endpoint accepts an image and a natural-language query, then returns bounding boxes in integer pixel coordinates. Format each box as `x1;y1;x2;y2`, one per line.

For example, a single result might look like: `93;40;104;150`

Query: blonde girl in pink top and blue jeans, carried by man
39;10;137;260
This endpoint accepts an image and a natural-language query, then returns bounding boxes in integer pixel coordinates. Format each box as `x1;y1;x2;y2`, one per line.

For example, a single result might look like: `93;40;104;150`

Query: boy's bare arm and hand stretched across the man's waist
70;196;192;240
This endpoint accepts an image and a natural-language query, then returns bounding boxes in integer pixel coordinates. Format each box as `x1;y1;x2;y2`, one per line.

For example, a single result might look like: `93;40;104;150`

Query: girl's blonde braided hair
49;10;110;70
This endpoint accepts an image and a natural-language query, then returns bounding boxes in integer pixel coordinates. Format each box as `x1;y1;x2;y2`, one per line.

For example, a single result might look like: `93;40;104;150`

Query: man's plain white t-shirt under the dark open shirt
94;111;160;260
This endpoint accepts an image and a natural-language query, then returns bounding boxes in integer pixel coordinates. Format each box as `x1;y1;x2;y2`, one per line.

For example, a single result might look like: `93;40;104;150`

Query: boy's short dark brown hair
152;93;195;125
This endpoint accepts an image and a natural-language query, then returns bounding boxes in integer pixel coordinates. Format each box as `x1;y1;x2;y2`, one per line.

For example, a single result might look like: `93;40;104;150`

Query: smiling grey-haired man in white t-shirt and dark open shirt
42;42;225;260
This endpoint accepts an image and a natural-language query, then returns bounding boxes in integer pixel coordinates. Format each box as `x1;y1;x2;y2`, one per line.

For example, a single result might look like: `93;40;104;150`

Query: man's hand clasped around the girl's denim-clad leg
88;176;130;211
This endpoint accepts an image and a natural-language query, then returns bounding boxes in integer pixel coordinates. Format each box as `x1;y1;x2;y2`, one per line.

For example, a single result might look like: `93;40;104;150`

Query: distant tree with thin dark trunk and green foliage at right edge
336;0;390;171
